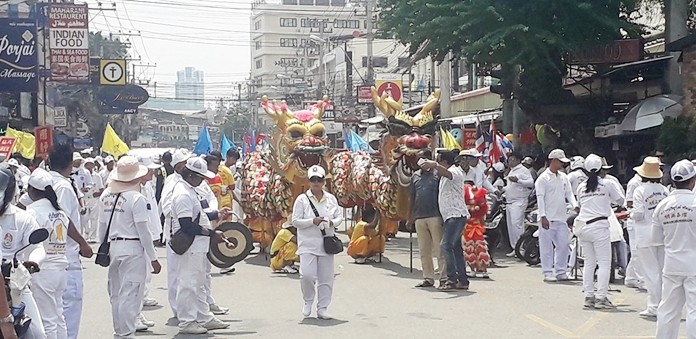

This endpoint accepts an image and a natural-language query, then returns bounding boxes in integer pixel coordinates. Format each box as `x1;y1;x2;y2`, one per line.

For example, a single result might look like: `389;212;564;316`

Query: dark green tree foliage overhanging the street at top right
378;0;640;102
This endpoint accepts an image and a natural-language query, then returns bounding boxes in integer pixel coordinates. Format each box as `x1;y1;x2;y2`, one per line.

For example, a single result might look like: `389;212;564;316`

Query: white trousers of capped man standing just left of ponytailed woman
539;221;570;276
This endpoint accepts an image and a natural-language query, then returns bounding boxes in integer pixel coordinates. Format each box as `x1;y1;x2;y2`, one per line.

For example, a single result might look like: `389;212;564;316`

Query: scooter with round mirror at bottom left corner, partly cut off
0;228;48;339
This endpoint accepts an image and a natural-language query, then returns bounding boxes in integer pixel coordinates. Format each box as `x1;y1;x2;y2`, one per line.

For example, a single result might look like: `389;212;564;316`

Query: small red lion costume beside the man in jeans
462;185;491;277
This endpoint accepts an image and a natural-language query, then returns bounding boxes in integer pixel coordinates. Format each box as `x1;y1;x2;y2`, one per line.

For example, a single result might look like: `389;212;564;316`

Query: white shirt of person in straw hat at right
631;182;669;248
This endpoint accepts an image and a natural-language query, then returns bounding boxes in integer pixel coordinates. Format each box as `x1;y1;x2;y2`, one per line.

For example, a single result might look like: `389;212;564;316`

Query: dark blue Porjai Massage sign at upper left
0;18;39;93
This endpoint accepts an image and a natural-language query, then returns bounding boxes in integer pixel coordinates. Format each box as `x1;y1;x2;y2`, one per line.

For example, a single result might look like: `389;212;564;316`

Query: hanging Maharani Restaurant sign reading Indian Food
48;4;89;83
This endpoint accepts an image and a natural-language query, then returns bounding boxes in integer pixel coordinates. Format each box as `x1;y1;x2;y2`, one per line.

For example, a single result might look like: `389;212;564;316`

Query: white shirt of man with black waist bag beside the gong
171;180;210;253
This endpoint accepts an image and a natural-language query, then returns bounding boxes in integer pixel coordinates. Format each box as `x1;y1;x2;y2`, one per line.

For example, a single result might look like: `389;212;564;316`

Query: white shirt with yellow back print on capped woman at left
27;199;70;271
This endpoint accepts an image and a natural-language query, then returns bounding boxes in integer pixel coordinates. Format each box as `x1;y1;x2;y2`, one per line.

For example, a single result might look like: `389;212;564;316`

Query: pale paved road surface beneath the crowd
80;233;686;339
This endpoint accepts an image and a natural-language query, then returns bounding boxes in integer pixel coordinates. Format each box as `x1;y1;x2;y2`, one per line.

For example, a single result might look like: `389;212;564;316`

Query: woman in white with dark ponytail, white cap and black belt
574;154;625;309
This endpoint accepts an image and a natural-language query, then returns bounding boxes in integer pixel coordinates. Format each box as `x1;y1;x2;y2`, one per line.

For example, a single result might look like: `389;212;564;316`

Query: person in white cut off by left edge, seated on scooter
0;164;46;339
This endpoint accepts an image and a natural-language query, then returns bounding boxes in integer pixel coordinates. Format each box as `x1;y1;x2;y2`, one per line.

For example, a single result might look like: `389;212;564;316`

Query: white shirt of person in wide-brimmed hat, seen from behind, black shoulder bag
99;188;157;261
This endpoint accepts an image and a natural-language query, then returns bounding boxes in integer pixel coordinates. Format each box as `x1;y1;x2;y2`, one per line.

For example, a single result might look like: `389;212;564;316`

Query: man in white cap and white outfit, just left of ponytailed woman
534;149;578;282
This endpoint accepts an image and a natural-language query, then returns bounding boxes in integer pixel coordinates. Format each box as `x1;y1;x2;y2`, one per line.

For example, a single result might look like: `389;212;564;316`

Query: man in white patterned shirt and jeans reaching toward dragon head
421;150;469;290
